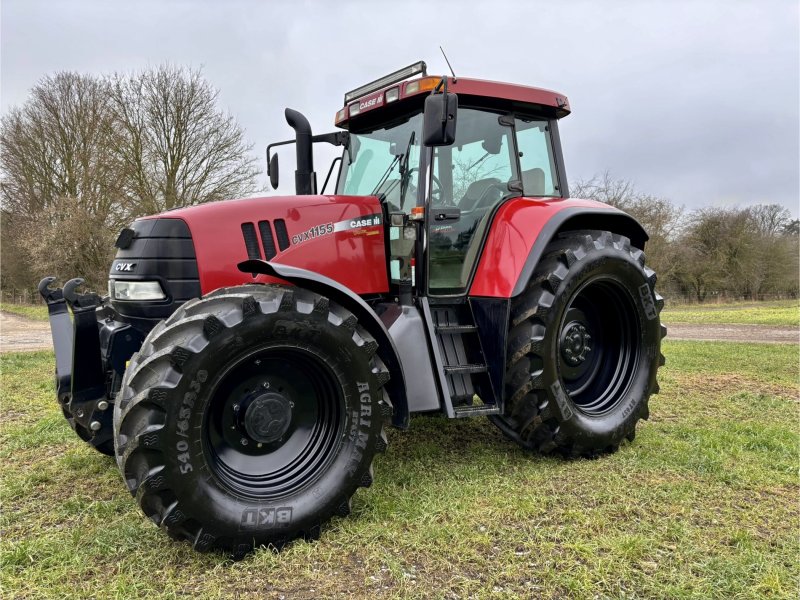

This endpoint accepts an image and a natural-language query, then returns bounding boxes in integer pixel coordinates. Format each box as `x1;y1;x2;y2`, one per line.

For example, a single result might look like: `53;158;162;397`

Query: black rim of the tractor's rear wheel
557;278;641;415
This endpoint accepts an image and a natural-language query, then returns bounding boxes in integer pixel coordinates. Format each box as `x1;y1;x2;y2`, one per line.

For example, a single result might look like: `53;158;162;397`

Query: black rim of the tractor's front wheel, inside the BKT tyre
204;348;344;499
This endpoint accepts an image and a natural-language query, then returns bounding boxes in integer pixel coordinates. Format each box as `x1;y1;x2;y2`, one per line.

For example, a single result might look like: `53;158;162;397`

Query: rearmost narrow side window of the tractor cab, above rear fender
515;117;561;196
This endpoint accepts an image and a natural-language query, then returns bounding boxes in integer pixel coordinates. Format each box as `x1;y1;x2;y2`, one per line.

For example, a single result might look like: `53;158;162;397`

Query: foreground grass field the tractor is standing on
0;341;800;598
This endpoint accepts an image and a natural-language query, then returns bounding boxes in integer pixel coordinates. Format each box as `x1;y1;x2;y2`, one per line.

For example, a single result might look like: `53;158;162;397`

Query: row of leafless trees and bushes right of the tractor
570;173;800;302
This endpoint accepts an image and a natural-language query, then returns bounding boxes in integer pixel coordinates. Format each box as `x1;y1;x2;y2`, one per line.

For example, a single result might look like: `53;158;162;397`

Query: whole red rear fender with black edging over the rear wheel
469;198;648;298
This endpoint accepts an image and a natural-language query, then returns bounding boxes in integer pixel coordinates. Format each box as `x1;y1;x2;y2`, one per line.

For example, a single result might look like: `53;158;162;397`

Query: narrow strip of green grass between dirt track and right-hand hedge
661;299;800;327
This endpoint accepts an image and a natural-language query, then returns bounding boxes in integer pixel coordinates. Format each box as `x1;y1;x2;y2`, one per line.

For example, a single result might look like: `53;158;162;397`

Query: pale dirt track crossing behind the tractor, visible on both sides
0;312;800;352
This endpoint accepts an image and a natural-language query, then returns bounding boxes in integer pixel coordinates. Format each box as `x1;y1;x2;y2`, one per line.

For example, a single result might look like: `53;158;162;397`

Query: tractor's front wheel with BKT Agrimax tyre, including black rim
114;285;392;558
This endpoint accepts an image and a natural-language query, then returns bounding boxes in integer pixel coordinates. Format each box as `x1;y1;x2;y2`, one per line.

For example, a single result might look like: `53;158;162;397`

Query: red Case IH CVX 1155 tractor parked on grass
40;62;665;555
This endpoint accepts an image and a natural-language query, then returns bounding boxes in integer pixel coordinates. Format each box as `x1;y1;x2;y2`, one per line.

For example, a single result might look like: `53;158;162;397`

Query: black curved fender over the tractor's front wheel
237;259;409;429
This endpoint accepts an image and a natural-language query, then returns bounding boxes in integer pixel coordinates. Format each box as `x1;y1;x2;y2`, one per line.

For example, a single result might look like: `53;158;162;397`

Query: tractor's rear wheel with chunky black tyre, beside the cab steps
491;231;666;457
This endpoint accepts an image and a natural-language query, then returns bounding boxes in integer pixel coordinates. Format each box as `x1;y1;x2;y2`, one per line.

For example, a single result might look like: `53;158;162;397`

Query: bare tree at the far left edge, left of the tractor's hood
0;73;123;287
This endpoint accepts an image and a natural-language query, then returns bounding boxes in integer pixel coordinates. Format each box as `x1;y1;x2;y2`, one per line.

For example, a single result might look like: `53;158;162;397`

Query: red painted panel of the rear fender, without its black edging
469;198;613;298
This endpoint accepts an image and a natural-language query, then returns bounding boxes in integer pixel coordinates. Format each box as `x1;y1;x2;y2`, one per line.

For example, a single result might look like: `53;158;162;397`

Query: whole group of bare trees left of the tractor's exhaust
0;65;259;290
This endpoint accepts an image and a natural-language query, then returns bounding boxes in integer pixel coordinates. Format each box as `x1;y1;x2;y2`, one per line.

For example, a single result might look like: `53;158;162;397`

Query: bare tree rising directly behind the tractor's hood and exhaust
111;66;259;214
